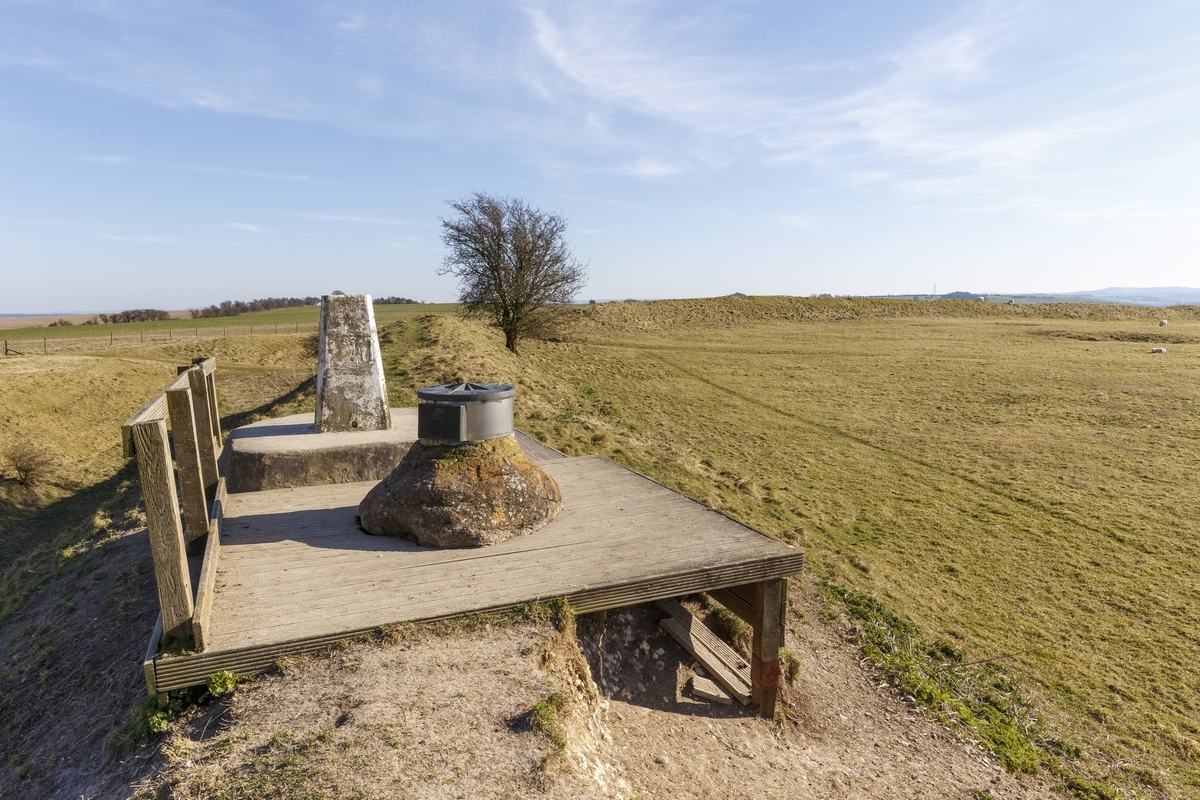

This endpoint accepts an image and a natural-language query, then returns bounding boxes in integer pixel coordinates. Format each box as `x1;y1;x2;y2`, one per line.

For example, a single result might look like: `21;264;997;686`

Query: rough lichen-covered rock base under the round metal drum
359;435;563;547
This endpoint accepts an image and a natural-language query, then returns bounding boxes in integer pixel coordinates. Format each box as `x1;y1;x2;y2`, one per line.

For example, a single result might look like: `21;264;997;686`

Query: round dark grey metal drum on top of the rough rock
416;383;517;444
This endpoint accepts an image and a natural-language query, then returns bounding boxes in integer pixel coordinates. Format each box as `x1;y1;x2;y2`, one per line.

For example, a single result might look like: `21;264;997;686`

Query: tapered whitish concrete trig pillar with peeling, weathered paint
316;293;391;433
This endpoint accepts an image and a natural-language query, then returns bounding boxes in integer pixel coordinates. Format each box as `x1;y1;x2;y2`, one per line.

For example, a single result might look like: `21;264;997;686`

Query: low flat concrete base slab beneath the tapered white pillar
221;408;416;492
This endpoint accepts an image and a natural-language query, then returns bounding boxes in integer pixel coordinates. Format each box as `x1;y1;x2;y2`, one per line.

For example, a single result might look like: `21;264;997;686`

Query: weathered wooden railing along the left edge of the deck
121;359;224;649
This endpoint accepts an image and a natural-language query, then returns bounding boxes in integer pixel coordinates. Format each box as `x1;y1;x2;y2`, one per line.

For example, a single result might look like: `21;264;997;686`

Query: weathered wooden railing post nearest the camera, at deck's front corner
133;419;194;643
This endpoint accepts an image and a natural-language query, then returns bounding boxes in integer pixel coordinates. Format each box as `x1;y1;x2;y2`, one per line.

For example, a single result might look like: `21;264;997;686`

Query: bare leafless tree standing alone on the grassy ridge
438;192;588;353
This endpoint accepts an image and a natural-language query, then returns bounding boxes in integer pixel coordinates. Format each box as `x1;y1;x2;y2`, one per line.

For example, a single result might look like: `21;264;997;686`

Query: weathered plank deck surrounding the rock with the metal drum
145;450;803;705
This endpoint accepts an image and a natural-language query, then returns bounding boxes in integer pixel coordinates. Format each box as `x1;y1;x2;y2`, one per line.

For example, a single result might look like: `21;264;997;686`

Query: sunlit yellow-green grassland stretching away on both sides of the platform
0;299;1200;798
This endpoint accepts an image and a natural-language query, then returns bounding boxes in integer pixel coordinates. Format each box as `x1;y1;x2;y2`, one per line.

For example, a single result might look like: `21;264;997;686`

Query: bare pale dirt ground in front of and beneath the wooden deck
88;585;1051;800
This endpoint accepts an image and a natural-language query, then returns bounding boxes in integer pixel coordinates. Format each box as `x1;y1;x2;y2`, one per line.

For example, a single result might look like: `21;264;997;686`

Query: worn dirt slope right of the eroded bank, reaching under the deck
566;585;1052;800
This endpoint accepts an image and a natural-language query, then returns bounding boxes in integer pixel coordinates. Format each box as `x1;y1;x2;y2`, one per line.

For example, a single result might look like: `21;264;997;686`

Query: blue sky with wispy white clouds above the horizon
0;0;1200;313
